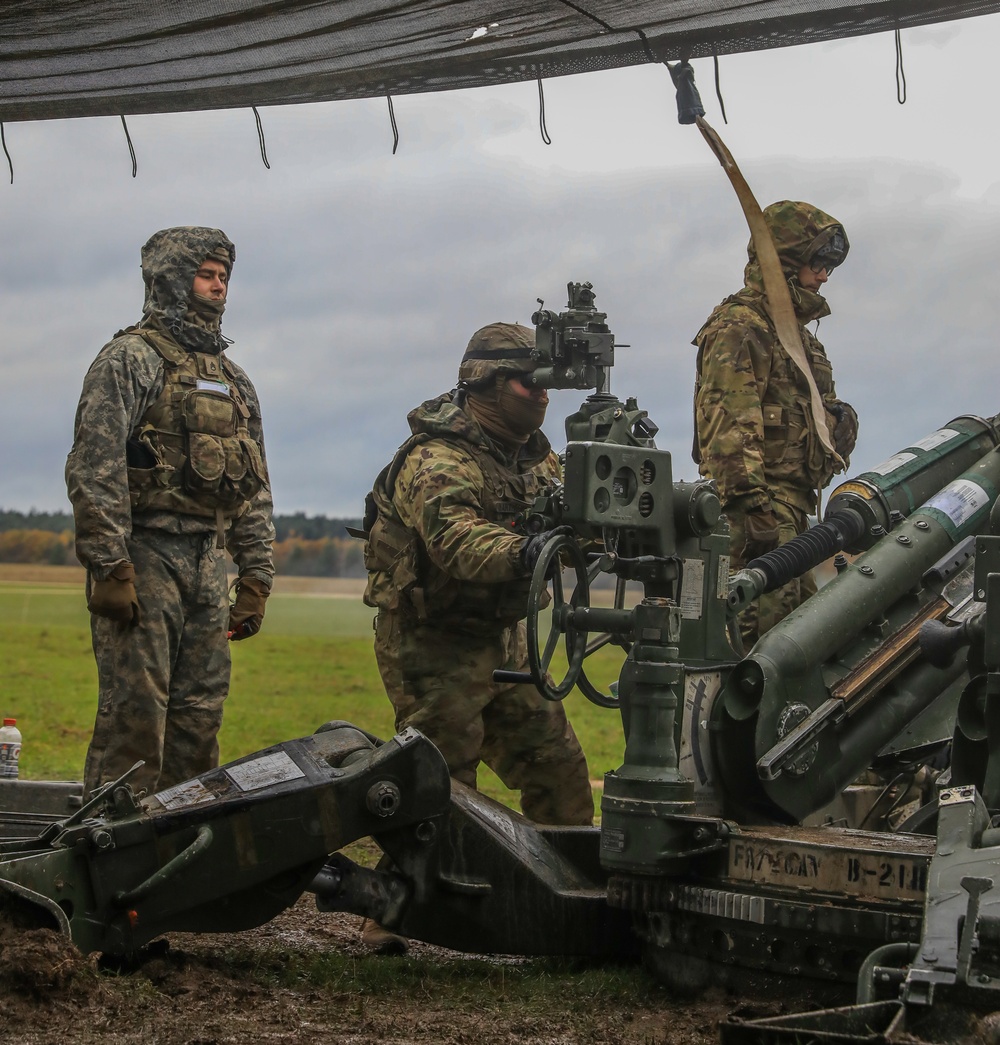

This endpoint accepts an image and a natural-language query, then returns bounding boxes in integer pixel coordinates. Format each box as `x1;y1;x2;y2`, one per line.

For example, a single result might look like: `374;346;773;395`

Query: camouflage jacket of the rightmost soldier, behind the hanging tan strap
694;199;853;512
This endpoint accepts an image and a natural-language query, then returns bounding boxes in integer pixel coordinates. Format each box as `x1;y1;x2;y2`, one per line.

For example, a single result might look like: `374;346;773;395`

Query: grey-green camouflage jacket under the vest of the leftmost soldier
66;229;274;584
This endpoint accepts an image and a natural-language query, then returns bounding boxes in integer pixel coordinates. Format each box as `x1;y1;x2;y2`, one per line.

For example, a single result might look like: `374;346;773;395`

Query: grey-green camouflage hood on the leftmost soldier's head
142;226;236;352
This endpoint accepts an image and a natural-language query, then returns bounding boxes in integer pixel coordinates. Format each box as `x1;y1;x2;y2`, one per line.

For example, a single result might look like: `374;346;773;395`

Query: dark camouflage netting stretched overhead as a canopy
0;0;1000;121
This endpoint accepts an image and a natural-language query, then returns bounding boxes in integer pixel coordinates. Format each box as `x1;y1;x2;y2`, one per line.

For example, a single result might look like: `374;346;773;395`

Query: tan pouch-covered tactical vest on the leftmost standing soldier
125;327;268;519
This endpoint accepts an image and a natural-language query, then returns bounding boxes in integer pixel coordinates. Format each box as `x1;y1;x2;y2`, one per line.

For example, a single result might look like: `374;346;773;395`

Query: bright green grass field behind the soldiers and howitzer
0;565;624;808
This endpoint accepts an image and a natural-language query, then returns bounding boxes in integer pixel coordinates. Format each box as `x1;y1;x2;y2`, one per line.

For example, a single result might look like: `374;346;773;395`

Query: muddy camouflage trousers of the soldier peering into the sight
375;610;594;825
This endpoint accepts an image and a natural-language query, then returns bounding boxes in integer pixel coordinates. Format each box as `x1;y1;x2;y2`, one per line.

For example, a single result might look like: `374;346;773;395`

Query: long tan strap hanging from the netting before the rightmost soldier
696;116;845;470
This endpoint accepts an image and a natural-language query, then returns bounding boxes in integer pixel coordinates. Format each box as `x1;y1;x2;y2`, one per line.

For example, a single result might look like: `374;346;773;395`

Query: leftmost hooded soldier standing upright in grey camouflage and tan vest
66;227;274;793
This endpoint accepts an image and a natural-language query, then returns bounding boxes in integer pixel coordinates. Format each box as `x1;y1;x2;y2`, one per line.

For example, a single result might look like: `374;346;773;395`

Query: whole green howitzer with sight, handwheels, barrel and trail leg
9;283;1000;1042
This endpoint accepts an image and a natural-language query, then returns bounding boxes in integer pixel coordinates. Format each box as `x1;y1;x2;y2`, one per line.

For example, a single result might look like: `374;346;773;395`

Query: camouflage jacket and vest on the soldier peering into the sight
365;393;560;632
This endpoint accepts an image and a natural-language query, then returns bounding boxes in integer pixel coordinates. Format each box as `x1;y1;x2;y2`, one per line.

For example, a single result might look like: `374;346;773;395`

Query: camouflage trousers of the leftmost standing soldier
84;528;230;794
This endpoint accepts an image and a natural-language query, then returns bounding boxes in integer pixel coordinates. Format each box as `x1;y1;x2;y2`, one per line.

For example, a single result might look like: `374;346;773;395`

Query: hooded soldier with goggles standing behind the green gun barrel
694;200;858;649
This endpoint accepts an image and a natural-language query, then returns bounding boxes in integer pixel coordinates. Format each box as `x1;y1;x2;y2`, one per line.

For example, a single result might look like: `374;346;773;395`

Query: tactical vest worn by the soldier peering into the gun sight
365;433;556;633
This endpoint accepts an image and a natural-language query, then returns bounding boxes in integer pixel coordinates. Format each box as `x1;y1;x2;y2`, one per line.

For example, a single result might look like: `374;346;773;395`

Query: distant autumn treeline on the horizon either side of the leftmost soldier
0;509;365;577
